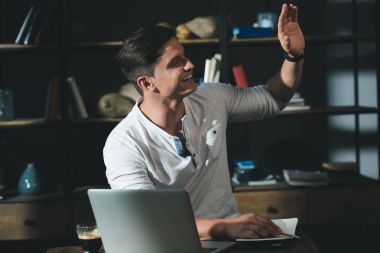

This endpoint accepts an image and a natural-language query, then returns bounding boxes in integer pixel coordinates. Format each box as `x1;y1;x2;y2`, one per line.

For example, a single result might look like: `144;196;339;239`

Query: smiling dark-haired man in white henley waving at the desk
104;4;305;239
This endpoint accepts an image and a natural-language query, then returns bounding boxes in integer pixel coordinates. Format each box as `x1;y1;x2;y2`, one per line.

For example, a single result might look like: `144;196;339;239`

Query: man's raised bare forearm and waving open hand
267;4;305;103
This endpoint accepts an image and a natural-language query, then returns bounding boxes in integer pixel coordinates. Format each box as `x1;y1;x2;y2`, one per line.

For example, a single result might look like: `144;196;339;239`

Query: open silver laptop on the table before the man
88;189;235;253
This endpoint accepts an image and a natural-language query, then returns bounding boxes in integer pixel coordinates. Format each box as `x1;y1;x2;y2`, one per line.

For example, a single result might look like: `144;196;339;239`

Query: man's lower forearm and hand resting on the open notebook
196;213;281;240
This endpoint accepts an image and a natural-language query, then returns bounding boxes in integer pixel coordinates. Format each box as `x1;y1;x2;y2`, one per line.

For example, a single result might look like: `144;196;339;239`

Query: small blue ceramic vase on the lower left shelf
18;163;40;195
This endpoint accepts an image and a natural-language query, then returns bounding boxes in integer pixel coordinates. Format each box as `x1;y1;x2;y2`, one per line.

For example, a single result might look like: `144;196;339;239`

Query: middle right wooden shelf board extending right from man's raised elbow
279;106;378;117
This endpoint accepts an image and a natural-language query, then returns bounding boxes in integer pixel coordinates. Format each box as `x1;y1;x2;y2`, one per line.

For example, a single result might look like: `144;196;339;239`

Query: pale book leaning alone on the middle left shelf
67;76;88;119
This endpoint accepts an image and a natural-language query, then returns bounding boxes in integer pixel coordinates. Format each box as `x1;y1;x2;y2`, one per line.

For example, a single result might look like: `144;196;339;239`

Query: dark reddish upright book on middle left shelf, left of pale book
44;76;59;120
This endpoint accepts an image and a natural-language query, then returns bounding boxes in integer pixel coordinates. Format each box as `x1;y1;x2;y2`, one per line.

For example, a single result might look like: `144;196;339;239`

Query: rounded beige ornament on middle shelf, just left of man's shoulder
98;93;134;118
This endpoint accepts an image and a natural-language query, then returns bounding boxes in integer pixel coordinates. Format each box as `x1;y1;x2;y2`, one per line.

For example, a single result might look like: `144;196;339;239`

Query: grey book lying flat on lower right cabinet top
283;170;329;186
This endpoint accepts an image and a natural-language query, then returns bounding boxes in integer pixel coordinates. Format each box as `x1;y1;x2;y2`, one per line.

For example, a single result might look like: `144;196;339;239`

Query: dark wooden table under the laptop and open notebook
46;235;319;253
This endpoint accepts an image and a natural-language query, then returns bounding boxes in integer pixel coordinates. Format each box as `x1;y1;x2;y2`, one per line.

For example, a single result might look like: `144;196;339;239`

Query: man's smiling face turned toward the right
150;38;197;99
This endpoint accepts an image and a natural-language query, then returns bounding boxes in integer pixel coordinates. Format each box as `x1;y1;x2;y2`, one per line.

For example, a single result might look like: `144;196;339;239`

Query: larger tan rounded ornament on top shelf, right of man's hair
185;16;218;39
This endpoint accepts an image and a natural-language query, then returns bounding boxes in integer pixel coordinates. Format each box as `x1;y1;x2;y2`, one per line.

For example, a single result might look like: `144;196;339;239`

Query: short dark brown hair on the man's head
116;25;175;83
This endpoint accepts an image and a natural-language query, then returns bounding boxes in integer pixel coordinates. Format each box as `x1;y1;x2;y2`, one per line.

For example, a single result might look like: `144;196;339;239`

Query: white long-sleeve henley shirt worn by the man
103;83;284;218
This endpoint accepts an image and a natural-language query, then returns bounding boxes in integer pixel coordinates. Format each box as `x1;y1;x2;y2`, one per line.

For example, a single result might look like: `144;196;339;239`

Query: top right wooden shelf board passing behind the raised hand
229;34;375;46
